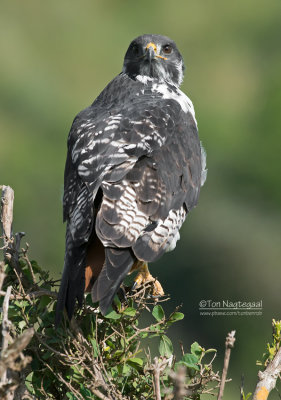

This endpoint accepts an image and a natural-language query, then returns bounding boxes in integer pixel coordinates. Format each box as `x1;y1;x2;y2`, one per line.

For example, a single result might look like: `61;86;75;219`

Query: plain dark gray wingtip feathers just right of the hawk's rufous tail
92;247;136;315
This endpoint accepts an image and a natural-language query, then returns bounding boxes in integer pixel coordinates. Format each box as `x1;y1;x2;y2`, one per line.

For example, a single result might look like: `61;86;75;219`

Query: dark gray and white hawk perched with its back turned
56;35;206;323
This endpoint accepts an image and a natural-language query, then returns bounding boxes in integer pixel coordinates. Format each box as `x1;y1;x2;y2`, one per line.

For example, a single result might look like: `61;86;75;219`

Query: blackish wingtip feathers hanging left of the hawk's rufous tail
55;232;87;326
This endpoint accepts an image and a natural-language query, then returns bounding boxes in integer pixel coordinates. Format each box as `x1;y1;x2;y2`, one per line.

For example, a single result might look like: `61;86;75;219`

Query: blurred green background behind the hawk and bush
0;0;281;400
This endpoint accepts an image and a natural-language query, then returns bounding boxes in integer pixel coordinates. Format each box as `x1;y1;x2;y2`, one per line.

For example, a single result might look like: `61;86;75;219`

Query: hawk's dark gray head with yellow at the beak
123;35;184;86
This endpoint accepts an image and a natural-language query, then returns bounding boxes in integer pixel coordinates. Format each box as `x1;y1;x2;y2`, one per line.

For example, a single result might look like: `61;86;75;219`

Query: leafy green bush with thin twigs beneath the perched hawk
1;250;220;400
